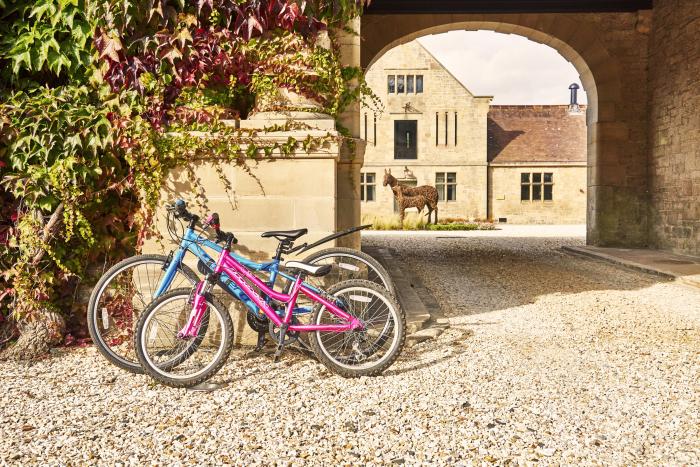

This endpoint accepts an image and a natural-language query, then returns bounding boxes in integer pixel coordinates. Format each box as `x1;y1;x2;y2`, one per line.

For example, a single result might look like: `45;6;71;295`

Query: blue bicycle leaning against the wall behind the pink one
87;200;394;373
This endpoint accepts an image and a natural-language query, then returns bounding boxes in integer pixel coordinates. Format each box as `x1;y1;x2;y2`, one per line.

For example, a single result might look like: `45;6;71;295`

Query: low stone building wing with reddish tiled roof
487;105;587;224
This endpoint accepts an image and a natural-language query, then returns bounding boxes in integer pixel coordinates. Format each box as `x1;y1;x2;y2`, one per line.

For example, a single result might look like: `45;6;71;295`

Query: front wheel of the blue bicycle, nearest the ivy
87;255;199;373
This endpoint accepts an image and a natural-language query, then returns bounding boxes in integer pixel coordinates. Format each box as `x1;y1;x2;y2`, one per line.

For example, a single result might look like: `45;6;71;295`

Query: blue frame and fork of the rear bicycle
153;228;318;315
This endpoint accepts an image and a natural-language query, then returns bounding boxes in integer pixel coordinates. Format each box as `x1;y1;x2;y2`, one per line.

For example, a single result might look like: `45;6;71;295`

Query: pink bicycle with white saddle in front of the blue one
134;221;406;387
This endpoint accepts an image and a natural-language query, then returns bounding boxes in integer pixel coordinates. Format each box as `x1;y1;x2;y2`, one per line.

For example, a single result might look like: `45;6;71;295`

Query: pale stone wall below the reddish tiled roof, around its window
489;164;586;224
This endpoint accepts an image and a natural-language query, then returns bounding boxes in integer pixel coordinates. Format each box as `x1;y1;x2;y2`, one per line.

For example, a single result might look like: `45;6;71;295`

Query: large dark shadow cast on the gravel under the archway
372;236;669;317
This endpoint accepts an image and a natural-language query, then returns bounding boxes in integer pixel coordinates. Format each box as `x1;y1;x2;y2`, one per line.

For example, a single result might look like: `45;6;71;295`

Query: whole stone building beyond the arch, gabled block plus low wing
360;41;586;223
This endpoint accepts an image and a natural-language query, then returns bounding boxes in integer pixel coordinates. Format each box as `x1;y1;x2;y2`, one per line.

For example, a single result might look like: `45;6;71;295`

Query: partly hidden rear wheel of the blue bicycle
304;247;395;295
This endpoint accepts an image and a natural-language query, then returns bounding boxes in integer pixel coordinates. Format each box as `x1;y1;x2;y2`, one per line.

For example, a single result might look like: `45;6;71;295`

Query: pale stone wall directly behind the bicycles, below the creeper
143;126;364;344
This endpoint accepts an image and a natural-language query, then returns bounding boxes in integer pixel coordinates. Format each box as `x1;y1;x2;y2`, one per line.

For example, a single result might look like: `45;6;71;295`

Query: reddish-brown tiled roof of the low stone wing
487;105;587;163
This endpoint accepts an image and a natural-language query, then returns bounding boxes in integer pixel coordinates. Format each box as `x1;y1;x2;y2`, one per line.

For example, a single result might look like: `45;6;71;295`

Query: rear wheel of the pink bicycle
309;280;406;378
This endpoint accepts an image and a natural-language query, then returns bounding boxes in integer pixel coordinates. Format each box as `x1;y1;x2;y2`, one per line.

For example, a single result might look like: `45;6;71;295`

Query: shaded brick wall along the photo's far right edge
649;0;700;255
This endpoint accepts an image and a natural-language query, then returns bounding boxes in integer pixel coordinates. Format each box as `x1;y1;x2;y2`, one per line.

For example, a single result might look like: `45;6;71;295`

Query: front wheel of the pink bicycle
134;289;233;388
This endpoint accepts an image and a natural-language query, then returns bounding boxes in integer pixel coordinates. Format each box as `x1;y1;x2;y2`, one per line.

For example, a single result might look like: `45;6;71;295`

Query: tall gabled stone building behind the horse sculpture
361;41;492;218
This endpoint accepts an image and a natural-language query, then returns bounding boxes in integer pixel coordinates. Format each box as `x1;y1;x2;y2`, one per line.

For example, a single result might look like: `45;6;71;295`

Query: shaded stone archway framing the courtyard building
361;12;649;246
